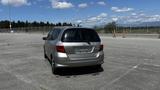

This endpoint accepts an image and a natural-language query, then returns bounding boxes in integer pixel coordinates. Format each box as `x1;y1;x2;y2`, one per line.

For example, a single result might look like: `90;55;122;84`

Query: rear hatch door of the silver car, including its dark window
62;28;100;60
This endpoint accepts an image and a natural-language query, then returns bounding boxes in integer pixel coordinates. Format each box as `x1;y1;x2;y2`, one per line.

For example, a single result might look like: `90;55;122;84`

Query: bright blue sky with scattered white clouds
0;0;160;25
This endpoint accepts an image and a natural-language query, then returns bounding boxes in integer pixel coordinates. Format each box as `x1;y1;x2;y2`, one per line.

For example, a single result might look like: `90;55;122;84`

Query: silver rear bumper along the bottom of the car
55;55;104;68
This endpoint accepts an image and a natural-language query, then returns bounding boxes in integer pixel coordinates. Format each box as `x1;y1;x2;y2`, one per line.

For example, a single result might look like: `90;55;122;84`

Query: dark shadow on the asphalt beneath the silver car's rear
57;66;104;76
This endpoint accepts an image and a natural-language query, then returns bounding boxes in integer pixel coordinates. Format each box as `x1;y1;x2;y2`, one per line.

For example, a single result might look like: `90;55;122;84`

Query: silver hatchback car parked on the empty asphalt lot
43;27;104;74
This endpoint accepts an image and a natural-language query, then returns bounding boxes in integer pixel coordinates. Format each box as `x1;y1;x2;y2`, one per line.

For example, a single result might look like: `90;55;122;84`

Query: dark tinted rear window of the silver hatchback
62;28;100;42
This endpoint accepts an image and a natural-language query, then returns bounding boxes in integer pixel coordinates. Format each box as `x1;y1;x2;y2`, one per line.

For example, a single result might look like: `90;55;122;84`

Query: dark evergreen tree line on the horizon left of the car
0;20;76;28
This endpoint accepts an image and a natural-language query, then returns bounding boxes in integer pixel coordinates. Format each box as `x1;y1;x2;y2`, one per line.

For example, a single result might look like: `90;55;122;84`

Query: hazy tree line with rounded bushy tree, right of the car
94;22;160;33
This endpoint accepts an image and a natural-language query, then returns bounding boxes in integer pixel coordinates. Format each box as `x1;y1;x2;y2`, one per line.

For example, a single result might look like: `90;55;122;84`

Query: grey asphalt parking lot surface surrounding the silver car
0;33;160;90
